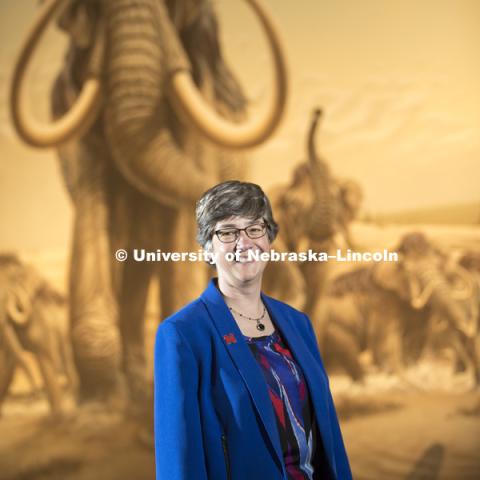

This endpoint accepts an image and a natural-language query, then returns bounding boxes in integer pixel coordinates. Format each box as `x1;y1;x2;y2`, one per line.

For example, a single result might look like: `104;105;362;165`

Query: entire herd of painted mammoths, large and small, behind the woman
0;0;480;416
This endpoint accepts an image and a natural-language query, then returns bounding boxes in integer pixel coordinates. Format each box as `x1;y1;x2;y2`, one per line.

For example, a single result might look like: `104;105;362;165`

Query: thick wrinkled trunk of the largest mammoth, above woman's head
104;0;214;206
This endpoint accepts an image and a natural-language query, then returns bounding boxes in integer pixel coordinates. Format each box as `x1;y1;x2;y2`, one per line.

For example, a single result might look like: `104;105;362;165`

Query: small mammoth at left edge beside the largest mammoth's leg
0;254;77;414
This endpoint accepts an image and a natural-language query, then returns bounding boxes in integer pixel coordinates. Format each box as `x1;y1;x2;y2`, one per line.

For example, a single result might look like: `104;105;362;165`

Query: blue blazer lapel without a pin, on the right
262;293;334;460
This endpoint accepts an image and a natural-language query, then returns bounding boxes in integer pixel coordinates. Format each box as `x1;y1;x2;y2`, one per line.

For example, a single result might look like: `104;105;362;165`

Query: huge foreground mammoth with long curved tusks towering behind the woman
11;0;287;414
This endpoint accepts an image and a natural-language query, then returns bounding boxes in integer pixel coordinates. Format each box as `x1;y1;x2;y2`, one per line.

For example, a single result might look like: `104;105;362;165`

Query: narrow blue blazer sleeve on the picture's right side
304;315;352;480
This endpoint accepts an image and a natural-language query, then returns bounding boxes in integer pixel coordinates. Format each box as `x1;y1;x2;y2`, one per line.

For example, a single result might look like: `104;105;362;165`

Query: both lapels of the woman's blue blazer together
200;279;334;474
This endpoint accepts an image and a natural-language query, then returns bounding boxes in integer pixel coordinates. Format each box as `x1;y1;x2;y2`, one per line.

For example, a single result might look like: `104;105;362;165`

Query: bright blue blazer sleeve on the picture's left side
154;321;207;480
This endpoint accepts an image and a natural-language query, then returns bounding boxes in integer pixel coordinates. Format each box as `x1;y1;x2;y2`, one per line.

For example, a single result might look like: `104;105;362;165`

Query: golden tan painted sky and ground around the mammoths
0;0;480;480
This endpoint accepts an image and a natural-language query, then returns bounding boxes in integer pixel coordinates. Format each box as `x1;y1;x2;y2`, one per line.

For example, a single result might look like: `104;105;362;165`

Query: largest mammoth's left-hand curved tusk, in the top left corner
10;0;105;148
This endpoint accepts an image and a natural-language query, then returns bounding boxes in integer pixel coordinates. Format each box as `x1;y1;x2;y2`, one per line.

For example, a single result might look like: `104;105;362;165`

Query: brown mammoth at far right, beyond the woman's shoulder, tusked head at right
314;233;478;382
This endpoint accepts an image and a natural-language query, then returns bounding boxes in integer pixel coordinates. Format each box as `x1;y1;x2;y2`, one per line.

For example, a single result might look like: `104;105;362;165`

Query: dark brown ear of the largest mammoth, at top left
57;0;98;49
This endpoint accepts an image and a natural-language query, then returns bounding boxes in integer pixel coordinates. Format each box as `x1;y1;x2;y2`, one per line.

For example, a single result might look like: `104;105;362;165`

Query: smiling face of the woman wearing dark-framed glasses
212;216;270;285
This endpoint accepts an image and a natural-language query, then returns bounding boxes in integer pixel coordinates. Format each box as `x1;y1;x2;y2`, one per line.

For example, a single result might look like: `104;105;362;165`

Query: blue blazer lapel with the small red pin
201;280;284;471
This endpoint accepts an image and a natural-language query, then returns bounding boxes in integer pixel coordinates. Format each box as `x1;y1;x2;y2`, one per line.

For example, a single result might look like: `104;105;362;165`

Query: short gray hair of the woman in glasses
196;180;278;250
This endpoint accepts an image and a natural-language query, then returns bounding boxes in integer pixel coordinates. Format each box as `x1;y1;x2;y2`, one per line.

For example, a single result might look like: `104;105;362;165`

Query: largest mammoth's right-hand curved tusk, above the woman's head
171;0;288;149
